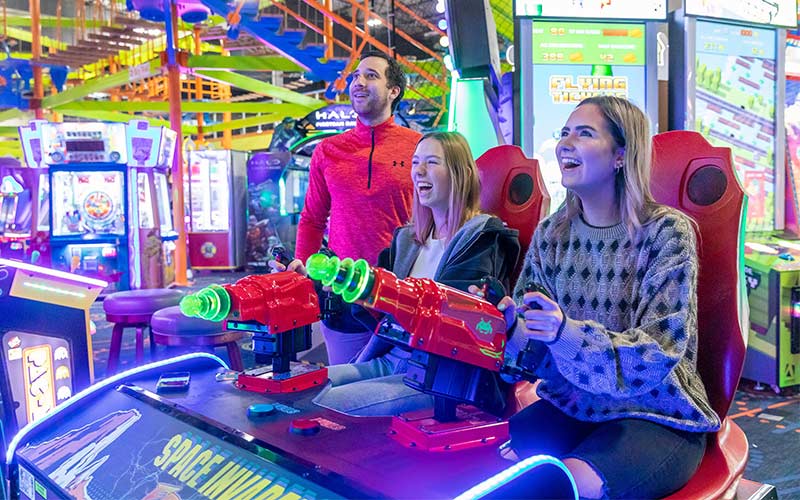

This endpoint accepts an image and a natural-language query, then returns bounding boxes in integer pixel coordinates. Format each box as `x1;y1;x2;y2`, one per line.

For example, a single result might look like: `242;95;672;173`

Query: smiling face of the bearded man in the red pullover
350;57;400;125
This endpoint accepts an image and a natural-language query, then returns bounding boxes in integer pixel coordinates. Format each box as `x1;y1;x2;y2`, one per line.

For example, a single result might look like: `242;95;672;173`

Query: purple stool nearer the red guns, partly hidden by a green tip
150;306;245;372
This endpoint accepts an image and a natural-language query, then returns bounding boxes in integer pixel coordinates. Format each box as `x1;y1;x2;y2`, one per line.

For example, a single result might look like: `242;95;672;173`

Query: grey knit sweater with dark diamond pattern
505;211;720;432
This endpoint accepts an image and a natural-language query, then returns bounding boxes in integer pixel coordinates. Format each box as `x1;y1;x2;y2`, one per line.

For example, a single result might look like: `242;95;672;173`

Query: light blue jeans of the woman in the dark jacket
314;348;433;417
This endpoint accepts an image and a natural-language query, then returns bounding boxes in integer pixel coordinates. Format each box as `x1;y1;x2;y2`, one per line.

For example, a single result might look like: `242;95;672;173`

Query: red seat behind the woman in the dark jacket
475;145;550;416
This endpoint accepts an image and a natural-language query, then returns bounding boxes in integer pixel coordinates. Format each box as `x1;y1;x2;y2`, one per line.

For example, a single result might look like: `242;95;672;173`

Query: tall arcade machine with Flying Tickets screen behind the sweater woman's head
514;0;664;213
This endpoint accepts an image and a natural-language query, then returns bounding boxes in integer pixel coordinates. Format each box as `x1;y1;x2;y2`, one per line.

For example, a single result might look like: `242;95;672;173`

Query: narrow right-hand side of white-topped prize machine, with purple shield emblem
126;120;178;288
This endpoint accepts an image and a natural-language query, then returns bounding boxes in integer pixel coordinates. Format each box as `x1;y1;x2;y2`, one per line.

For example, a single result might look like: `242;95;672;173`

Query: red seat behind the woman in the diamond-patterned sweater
650;130;748;499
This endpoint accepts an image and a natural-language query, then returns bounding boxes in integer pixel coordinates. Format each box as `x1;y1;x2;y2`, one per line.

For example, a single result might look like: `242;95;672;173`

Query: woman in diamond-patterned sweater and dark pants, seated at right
494;96;720;498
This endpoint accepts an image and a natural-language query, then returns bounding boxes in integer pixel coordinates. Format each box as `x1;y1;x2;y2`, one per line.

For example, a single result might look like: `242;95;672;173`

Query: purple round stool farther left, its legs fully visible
103;288;183;375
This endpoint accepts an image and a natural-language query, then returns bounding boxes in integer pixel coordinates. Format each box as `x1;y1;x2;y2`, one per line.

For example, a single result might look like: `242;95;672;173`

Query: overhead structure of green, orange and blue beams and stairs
0;0;513;155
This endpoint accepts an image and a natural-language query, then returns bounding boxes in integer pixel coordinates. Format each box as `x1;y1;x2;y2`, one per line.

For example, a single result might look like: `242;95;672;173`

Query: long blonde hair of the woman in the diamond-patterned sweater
556;96;671;240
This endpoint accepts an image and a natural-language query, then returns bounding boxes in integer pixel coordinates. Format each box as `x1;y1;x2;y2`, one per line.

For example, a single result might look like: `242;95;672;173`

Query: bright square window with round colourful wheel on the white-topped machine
51;170;125;236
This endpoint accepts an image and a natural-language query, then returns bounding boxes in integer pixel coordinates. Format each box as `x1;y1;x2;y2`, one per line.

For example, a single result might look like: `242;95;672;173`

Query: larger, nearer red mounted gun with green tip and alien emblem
306;254;508;451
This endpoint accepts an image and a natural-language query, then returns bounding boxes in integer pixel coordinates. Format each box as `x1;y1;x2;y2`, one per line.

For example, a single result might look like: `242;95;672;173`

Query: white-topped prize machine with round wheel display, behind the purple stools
42;121;180;293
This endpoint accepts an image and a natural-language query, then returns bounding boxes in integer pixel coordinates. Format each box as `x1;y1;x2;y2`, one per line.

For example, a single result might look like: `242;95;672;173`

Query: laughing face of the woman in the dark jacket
411;138;452;219
